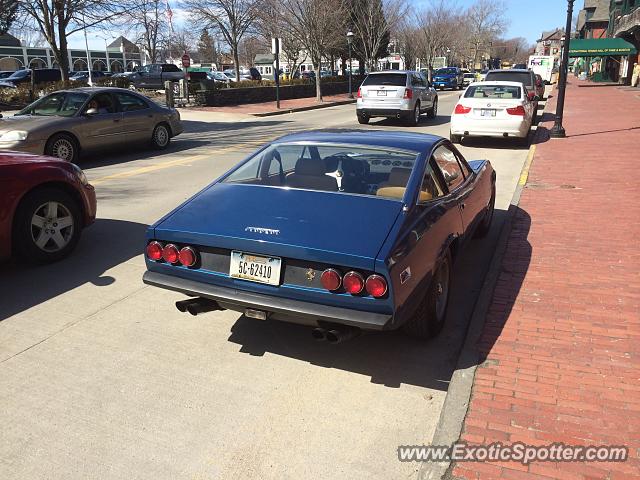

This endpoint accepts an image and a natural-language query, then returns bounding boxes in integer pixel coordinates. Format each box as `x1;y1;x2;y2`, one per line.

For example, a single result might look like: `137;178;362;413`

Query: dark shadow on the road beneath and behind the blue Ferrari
229;210;507;391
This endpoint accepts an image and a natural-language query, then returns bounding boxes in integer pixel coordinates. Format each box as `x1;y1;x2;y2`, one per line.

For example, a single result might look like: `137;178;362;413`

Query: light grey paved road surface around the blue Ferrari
0;92;528;480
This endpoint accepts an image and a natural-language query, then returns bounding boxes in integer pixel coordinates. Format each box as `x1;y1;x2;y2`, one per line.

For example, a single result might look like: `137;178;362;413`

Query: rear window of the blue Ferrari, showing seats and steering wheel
223;143;418;200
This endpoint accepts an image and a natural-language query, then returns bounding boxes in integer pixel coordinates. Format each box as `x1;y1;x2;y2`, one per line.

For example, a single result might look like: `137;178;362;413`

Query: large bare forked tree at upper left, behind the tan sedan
20;0;126;82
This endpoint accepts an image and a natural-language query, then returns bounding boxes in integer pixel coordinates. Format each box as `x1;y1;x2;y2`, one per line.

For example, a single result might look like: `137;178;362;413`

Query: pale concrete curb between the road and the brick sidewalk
417;94;547;480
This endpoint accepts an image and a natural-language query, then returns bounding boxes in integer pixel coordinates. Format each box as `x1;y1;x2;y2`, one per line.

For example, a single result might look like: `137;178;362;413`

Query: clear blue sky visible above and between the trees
60;0;568;49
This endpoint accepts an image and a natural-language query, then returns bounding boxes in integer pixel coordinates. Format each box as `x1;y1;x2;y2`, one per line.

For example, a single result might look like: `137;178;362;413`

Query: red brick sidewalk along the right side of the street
452;78;640;480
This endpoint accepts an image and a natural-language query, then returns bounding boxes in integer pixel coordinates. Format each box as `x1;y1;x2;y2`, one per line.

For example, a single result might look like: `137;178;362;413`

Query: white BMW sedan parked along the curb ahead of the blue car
450;81;536;144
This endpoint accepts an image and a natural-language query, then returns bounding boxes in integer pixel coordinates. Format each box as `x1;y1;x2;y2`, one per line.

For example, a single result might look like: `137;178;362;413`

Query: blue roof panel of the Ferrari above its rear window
273;129;442;152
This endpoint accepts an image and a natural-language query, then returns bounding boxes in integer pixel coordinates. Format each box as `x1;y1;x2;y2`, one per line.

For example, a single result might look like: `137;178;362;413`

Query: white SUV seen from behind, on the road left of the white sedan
356;70;438;126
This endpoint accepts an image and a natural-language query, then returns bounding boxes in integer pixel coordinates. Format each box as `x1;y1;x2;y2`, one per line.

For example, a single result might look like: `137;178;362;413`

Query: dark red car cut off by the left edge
0;151;96;263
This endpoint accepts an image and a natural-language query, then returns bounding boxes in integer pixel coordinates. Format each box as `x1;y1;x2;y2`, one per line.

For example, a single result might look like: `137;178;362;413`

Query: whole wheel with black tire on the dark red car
13;187;82;263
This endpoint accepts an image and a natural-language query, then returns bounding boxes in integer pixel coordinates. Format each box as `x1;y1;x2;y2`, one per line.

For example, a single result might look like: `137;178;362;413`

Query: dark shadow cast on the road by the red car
0;219;147;321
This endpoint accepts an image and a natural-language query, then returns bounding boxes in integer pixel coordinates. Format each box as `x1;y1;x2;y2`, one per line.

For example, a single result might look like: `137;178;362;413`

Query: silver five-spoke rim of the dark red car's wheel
31;201;74;253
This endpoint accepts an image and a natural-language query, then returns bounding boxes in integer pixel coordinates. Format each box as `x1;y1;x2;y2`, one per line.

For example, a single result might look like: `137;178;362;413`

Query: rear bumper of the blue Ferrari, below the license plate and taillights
142;271;393;330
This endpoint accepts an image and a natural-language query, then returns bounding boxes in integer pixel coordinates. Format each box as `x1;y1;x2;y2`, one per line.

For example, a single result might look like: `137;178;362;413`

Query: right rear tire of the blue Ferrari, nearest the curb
402;250;452;339
